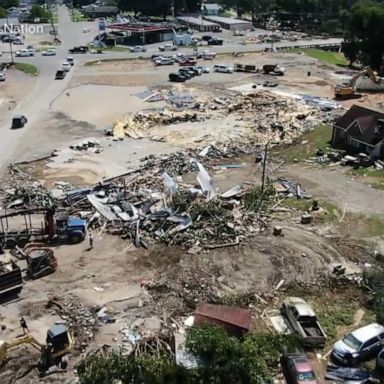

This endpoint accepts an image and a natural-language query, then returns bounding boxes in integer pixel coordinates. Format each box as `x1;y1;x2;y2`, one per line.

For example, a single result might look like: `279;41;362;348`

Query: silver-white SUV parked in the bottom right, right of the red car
332;323;384;365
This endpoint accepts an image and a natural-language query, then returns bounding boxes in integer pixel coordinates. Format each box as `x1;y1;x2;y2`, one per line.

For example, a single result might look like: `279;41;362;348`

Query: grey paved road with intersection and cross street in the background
0;6;340;172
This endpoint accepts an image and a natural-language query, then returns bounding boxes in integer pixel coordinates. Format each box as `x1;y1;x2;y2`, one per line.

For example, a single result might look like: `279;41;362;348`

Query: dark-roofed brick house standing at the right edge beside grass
332;105;384;159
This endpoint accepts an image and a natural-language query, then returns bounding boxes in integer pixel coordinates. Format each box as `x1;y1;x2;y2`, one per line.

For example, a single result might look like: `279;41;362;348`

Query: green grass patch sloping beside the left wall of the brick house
272;124;332;162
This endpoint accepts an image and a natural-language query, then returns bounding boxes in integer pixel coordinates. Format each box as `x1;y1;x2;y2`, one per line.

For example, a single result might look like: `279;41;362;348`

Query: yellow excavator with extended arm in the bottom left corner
0;324;74;372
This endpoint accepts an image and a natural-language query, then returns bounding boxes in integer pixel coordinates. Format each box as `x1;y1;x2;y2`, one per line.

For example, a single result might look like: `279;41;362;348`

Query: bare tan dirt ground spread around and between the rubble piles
0;49;384;384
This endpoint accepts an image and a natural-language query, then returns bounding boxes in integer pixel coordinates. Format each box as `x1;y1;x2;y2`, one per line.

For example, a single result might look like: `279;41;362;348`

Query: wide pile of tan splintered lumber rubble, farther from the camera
107;90;338;143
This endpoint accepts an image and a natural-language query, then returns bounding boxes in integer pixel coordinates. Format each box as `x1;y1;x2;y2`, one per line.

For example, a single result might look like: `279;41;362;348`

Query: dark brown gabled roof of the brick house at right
335;105;384;144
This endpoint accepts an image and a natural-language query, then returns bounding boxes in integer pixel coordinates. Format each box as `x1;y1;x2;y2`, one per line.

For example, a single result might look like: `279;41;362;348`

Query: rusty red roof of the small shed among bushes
195;303;251;330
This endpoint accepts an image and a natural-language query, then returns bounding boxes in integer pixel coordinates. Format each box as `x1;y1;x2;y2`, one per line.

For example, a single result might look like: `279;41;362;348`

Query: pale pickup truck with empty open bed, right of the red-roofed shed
282;297;327;348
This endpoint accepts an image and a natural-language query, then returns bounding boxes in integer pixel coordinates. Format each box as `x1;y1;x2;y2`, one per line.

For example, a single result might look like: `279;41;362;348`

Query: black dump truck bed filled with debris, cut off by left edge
0;254;23;298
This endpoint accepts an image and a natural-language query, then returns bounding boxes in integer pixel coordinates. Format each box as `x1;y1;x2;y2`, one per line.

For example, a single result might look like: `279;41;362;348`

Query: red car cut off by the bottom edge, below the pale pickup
280;353;318;384
